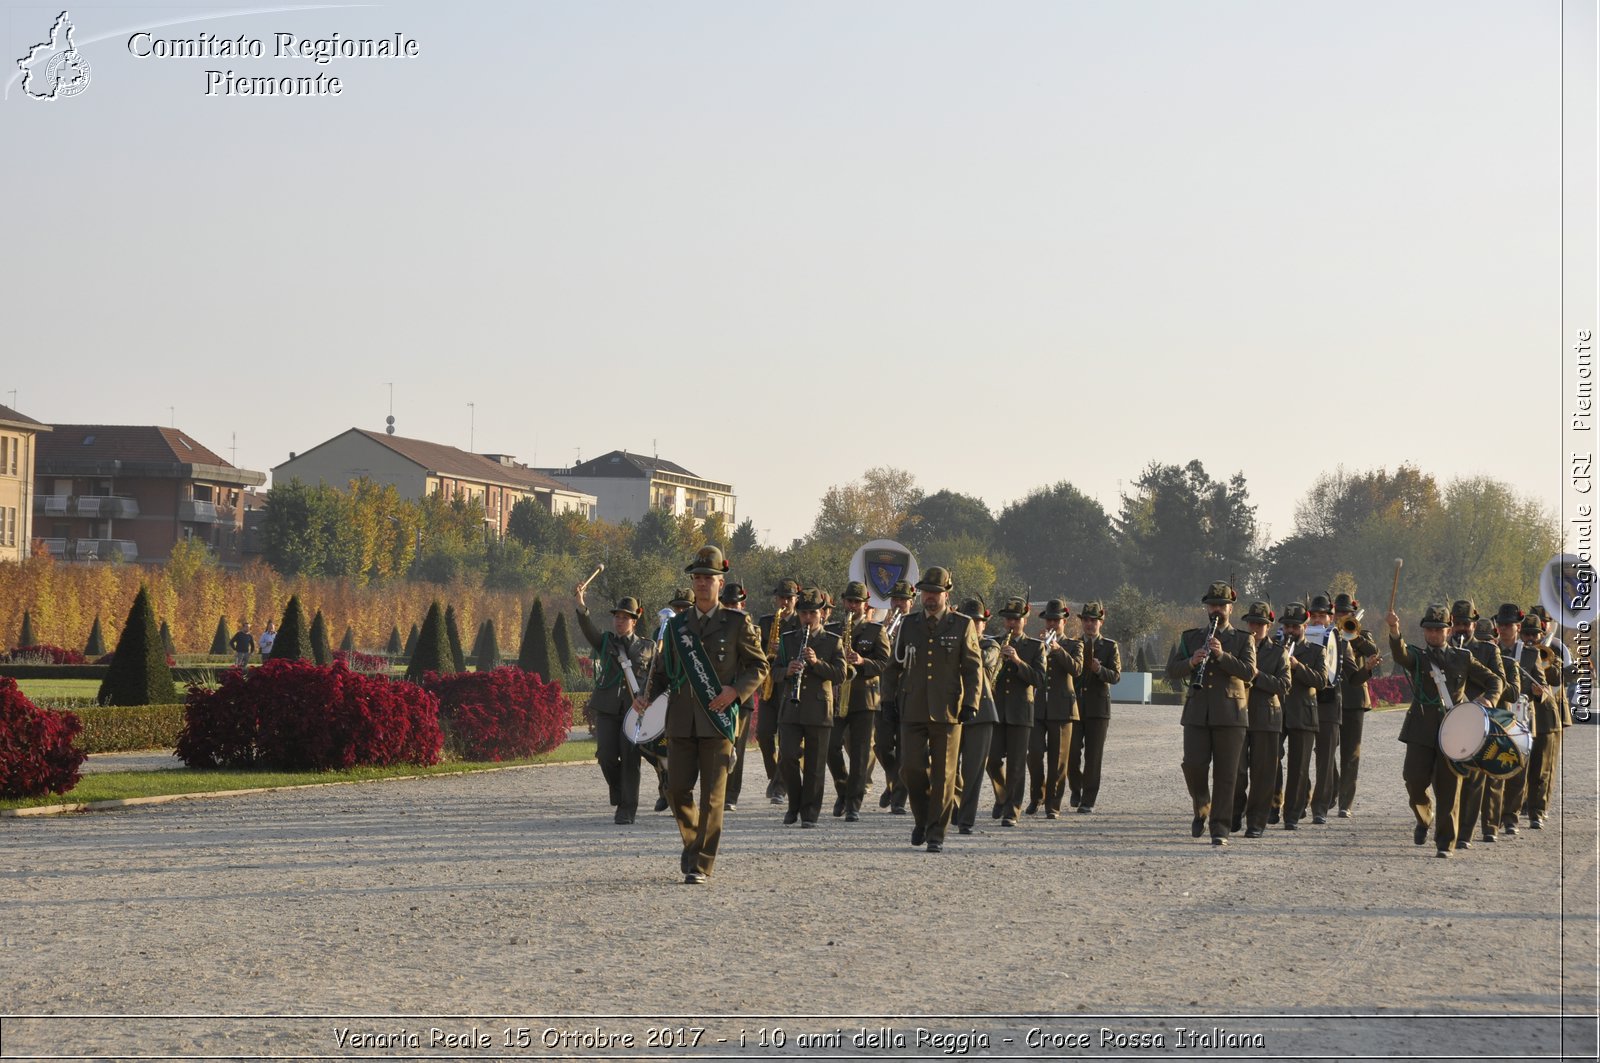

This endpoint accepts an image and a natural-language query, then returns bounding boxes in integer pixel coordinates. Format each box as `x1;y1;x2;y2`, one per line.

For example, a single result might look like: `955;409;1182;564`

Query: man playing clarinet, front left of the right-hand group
1166;581;1256;845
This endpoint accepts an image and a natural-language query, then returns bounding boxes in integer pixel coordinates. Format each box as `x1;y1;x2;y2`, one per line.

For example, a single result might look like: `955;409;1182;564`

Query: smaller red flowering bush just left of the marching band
422;668;573;760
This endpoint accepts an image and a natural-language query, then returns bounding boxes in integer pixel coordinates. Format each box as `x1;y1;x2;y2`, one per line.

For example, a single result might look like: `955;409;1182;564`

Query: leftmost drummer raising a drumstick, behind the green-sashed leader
574;586;656;823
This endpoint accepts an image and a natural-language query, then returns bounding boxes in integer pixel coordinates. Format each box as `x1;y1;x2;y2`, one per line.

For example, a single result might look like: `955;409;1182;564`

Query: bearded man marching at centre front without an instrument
893;568;982;853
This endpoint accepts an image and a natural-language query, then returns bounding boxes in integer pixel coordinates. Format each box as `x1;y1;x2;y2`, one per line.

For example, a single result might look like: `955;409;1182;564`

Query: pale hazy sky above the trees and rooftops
0;0;1571;543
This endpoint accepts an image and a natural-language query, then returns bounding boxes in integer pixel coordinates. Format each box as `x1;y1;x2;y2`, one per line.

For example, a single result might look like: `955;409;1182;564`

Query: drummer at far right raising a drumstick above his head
1384;605;1501;856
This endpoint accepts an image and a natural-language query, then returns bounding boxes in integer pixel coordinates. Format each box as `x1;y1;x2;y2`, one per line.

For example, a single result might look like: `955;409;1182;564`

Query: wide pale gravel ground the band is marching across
0;706;1600;1058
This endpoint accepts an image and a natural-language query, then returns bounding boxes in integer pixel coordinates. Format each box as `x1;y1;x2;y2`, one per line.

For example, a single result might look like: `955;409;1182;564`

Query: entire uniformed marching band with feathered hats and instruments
578;546;1587;884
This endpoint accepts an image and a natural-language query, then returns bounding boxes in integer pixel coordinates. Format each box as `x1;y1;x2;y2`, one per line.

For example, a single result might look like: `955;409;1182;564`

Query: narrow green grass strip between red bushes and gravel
0;740;595;808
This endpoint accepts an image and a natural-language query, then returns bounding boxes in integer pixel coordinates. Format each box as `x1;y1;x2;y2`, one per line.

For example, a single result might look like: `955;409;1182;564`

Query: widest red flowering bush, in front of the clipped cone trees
178;658;445;772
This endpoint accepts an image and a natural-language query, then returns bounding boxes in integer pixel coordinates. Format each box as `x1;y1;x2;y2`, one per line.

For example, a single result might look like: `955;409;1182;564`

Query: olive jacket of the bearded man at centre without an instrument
891;608;982;724
